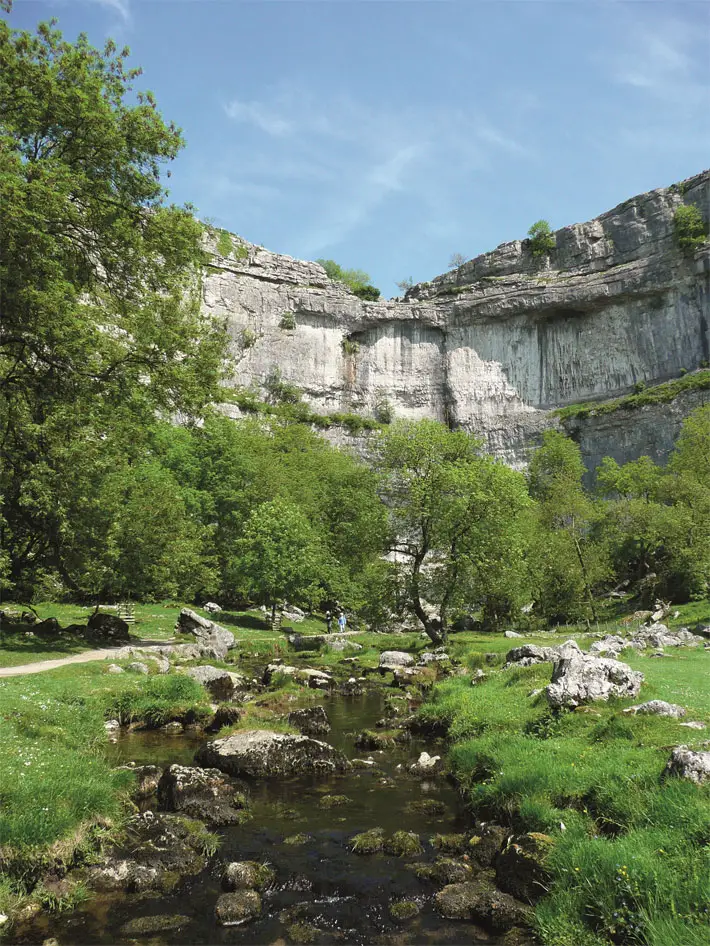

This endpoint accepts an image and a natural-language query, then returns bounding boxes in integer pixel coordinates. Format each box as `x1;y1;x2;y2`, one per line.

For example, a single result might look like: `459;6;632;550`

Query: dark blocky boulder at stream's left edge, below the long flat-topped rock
158;765;248;825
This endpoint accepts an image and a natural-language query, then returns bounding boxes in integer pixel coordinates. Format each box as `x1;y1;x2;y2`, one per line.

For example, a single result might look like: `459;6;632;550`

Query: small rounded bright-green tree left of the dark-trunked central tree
237;499;328;621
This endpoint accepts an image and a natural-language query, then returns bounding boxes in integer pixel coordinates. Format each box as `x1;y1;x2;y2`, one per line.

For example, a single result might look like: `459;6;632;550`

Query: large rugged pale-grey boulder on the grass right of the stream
545;653;643;707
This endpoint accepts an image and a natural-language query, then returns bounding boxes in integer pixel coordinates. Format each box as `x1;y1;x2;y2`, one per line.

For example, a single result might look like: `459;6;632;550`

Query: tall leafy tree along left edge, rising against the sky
0;11;222;590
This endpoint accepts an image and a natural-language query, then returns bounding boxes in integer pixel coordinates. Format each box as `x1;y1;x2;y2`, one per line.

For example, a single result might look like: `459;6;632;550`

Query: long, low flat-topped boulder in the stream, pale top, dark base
195;729;349;778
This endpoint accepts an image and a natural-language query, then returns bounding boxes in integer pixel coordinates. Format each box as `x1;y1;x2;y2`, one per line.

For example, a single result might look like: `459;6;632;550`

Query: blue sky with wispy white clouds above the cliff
6;0;710;296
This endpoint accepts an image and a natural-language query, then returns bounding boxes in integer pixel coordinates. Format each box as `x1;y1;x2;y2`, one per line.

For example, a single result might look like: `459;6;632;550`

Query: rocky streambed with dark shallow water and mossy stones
11;686;531;946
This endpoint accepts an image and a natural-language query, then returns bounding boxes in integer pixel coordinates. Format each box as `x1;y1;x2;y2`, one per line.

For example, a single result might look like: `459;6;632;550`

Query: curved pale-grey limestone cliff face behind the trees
203;171;710;465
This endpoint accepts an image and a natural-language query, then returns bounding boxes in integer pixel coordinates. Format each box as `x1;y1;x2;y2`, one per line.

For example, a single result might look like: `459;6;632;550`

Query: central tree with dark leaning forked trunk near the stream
379;421;528;643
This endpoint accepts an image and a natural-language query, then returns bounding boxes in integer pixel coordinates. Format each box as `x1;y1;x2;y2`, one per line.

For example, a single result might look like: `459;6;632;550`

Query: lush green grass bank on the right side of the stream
421;624;710;946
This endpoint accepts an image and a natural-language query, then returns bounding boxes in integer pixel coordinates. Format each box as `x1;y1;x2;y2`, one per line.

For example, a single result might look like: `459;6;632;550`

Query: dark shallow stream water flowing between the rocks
24;690;499;946
